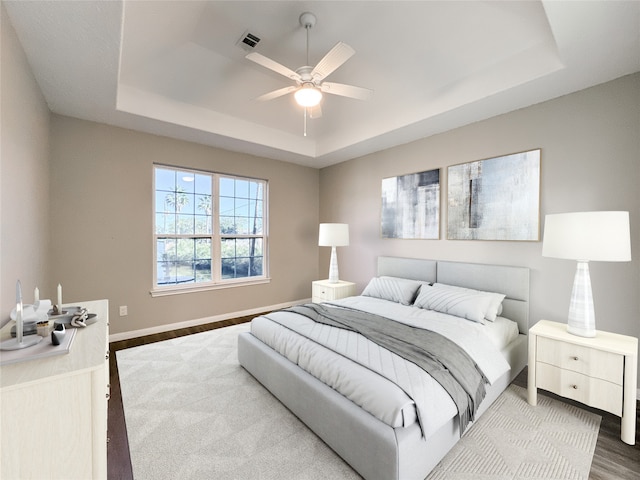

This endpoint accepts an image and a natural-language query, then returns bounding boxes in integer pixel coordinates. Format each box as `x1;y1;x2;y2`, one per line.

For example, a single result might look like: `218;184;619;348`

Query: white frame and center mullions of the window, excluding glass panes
149;163;270;297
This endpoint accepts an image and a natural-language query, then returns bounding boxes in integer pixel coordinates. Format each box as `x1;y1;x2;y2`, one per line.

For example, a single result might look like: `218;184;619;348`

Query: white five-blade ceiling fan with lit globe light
245;12;373;136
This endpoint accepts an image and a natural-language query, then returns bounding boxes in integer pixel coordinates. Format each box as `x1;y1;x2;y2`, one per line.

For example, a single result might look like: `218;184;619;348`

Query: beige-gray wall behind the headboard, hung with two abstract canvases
319;74;640;388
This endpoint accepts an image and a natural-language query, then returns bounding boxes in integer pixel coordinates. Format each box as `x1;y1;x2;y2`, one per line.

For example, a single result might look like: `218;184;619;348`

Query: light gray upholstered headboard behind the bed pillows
378;257;529;335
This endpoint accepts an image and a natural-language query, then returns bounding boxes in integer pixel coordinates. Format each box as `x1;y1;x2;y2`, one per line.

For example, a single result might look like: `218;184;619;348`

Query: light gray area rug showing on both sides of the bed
116;324;600;480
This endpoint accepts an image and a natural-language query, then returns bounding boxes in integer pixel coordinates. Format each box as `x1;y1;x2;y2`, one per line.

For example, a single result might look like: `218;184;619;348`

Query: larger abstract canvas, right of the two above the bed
447;150;540;241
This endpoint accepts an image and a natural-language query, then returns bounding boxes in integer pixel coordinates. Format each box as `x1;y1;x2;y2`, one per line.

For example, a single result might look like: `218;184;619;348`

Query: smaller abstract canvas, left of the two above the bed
382;170;440;240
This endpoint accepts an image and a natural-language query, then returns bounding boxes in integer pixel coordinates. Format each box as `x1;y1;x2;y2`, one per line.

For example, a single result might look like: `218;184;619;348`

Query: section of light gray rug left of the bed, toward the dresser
116;324;360;480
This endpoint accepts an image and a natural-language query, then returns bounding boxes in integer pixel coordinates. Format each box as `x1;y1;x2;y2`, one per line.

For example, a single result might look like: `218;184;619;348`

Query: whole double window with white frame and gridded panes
152;166;267;293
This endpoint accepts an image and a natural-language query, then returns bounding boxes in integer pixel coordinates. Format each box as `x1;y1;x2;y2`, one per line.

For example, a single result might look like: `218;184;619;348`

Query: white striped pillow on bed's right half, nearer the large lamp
414;283;505;324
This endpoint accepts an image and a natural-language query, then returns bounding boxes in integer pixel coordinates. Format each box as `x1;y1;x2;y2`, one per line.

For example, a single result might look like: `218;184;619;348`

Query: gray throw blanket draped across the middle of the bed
286;304;489;434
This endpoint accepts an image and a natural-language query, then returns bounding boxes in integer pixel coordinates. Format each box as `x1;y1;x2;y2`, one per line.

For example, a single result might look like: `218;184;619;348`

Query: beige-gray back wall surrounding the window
51;115;319;334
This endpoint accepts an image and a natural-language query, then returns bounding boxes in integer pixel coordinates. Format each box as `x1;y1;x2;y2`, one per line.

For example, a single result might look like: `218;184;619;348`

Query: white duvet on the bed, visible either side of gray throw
251;296;518;437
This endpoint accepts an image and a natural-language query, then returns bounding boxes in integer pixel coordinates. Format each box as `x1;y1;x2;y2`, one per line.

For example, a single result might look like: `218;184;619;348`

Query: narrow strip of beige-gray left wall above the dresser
0;3;53;325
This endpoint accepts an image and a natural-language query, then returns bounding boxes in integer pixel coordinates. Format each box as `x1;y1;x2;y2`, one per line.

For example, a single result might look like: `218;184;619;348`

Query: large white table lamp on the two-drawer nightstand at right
542;212;631;337
